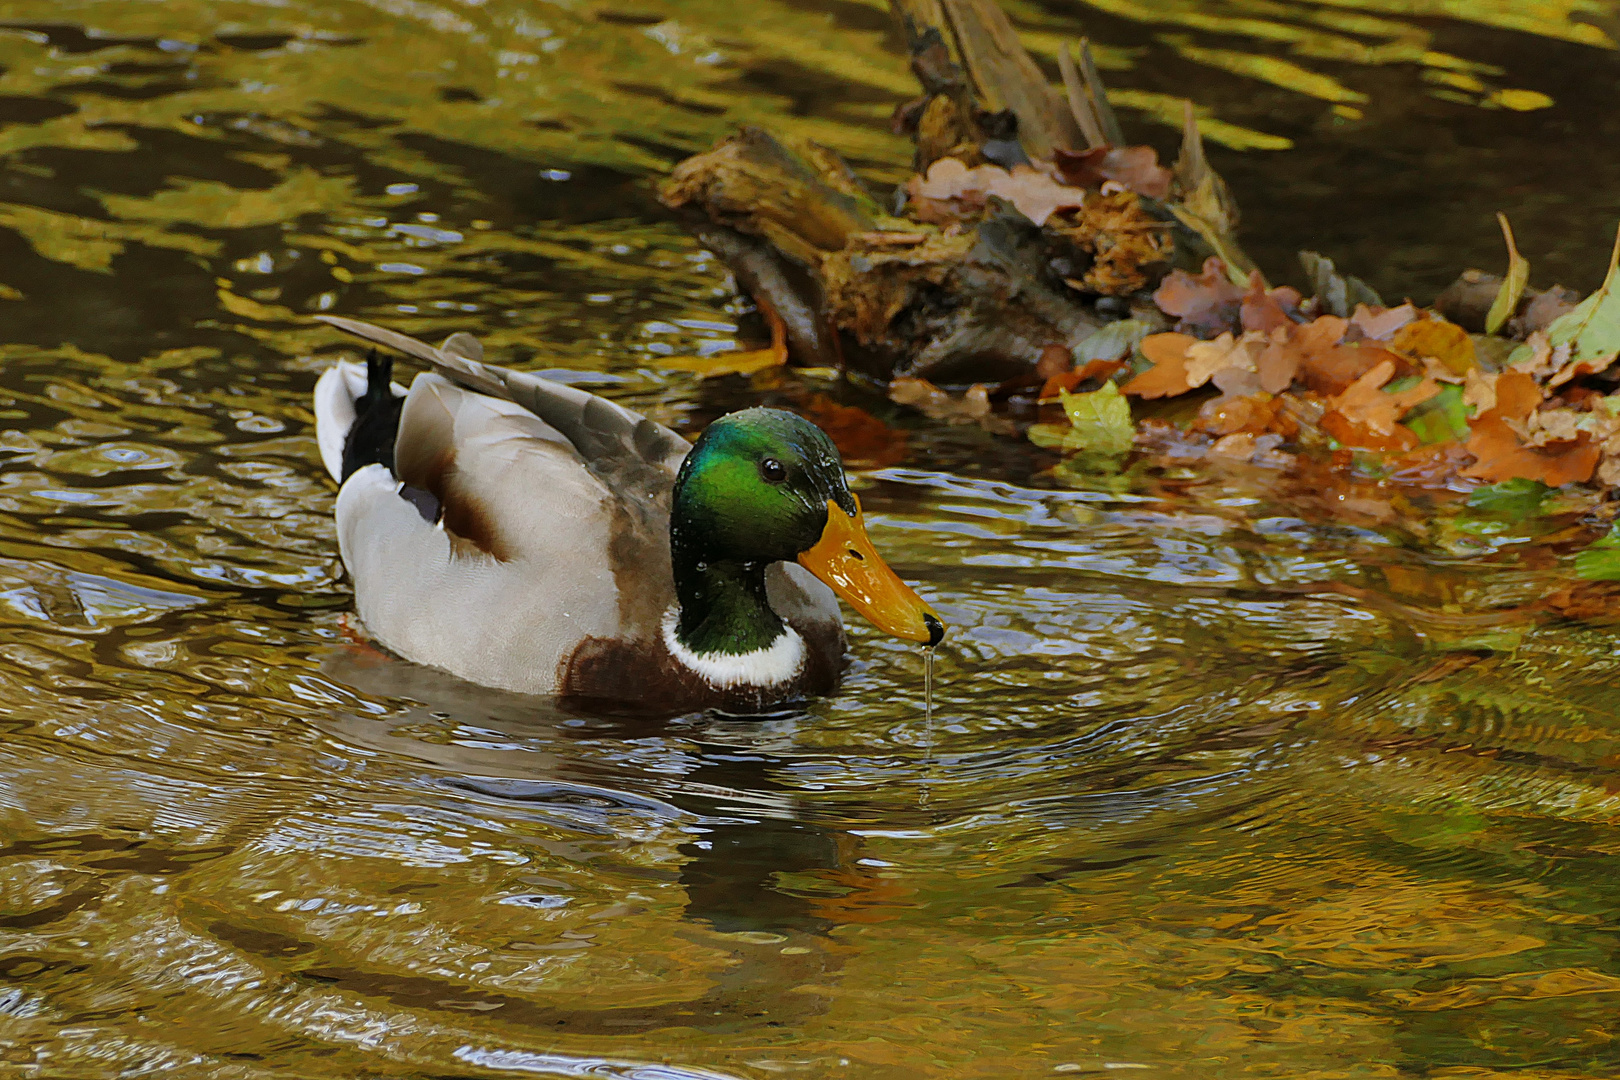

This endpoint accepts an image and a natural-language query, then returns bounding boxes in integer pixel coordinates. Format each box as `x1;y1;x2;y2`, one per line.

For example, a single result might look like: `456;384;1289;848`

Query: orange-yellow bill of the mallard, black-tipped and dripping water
799;499;944;646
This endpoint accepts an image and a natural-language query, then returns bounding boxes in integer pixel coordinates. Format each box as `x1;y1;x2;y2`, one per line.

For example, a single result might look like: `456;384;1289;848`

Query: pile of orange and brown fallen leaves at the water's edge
1030;244;1620;487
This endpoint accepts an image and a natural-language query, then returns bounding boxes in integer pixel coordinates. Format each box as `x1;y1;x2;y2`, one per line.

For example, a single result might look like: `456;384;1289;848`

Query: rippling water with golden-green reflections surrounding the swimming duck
0;0;1620;1080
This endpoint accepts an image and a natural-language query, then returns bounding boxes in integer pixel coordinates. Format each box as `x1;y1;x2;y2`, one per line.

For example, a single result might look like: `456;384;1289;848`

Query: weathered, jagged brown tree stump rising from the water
659;0;1252;382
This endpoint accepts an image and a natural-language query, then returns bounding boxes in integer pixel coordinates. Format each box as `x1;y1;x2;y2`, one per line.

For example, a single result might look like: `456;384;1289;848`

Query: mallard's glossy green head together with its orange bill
669;408;944;644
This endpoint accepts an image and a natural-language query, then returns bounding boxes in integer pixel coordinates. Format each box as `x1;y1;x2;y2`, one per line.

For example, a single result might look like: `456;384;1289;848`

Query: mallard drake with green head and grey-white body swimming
314;316;944;712
